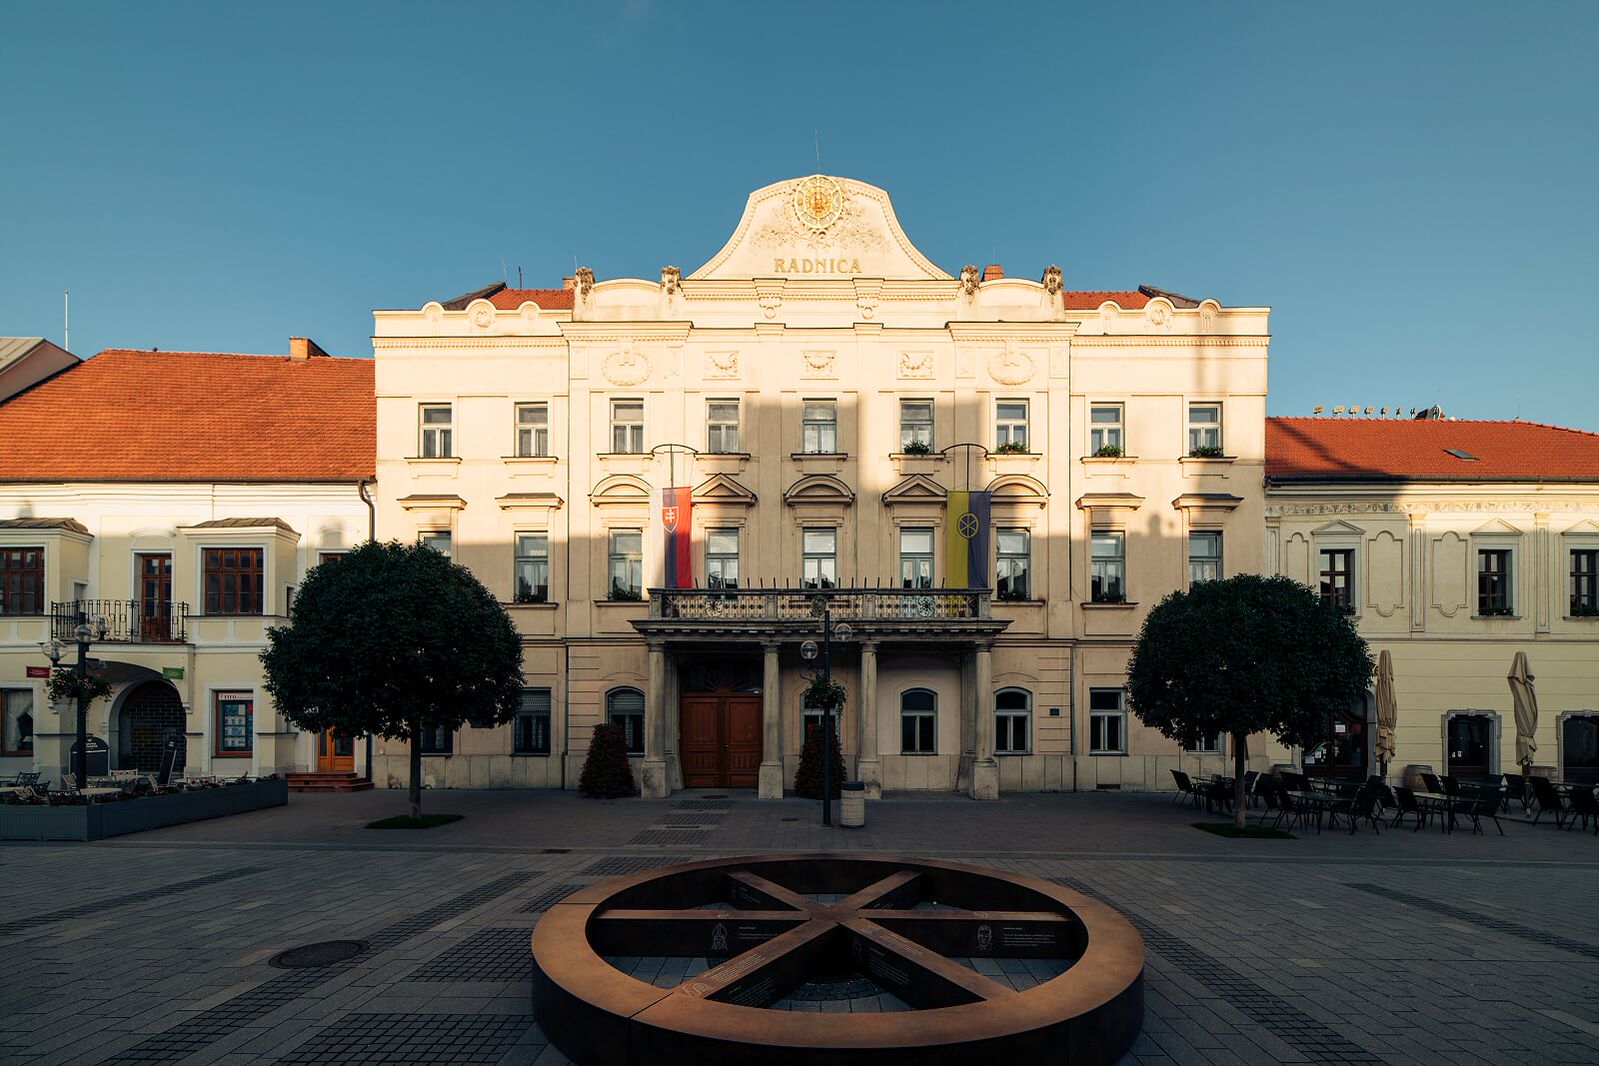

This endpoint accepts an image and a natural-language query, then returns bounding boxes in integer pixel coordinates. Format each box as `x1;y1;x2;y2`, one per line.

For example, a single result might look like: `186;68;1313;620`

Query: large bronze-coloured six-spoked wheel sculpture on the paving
532;853;1145;1066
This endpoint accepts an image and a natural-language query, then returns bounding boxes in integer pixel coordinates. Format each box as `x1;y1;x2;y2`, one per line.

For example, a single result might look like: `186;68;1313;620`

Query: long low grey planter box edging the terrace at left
0;777;289;841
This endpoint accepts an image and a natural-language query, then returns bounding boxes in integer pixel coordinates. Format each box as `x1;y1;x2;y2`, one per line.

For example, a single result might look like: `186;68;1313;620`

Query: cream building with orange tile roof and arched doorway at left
0;340;373;782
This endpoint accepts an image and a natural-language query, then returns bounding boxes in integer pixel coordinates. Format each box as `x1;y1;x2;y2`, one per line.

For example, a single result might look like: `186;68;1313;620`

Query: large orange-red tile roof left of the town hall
0;348;377;481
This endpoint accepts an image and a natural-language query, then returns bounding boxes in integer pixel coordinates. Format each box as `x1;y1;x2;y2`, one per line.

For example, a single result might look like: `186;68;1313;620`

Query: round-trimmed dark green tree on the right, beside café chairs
1127;574;1372;828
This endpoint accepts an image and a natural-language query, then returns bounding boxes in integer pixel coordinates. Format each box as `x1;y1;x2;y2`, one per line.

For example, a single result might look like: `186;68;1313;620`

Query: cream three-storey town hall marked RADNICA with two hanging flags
374;174;1268;798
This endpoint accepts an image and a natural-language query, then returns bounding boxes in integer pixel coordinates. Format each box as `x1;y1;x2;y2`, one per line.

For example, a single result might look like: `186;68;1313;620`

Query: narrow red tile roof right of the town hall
1266;417;1599;481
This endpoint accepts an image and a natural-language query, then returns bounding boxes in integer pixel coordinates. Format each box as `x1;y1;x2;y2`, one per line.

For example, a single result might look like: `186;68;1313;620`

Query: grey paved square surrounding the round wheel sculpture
0;791;1599;1066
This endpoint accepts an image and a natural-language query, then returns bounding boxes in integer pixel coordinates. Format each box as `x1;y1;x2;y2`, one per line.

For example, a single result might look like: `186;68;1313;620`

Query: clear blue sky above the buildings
0;0;1599;428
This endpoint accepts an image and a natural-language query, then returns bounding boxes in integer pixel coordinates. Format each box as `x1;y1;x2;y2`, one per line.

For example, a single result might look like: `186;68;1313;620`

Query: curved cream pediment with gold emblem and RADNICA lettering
689;174;951;281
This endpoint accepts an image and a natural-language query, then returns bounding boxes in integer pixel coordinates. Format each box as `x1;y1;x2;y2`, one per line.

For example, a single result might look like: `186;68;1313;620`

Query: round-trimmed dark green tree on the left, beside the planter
261;542;521;820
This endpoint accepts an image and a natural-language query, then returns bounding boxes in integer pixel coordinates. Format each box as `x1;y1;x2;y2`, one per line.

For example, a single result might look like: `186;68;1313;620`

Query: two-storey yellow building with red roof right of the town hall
1266;412;1599;780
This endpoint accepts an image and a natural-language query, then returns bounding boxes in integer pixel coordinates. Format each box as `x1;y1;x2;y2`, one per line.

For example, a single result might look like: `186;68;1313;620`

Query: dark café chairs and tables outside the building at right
1172;770;1599;836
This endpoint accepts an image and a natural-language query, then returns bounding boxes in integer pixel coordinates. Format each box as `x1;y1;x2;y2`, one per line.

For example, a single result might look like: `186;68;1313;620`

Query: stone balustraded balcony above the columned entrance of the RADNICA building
633;588;1011;639
